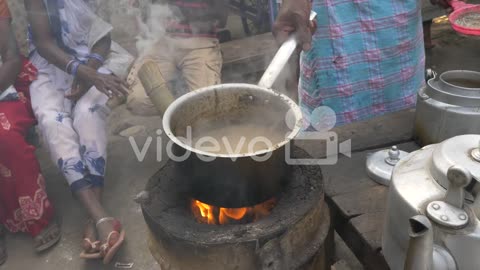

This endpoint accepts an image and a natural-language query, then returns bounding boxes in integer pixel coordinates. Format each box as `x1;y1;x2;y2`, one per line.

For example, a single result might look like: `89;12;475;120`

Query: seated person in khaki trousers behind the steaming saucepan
127;0;228;115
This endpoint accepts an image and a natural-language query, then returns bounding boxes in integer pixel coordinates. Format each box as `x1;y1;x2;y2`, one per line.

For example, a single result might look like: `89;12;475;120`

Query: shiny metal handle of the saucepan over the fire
258;11;317;89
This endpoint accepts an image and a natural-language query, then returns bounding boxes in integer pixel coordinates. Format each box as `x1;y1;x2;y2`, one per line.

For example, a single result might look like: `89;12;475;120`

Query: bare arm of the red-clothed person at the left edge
0;19;22;93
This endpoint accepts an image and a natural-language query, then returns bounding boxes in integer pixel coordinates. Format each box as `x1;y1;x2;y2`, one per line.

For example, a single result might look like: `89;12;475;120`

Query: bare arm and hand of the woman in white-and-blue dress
25;0;128;96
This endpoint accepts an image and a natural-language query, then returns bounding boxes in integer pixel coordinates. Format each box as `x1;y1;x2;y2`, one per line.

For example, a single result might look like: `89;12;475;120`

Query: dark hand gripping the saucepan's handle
273;0;315;51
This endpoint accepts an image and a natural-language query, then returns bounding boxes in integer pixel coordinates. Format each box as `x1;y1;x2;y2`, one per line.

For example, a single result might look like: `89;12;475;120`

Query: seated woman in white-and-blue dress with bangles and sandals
25;0;131;263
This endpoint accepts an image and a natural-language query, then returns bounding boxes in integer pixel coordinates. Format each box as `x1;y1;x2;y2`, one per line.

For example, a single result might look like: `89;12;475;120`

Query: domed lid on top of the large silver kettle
429;135;480;188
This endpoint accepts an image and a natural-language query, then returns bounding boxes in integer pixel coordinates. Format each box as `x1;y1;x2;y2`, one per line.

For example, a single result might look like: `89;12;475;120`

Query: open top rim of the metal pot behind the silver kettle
425;70;480;107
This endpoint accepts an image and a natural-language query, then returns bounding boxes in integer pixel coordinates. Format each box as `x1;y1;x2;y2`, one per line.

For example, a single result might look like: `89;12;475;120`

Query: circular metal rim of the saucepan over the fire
162;83;303;158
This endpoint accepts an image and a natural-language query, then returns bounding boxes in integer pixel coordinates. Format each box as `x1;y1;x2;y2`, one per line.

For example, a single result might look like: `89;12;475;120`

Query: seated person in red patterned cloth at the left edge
0;0;61;265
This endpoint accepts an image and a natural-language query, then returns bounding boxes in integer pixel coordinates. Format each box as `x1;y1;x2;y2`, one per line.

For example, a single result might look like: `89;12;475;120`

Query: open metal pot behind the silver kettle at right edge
415;70;480;145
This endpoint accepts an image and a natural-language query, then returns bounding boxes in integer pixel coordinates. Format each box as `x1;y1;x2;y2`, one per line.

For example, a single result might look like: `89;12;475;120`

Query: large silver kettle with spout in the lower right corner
382;135;480;270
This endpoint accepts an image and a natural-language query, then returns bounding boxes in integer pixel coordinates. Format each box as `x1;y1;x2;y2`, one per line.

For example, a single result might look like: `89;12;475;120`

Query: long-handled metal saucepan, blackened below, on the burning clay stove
163;13;316;208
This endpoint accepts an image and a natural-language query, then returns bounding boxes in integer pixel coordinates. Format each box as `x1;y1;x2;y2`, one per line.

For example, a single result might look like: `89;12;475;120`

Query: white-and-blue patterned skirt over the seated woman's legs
30;67;110;185
